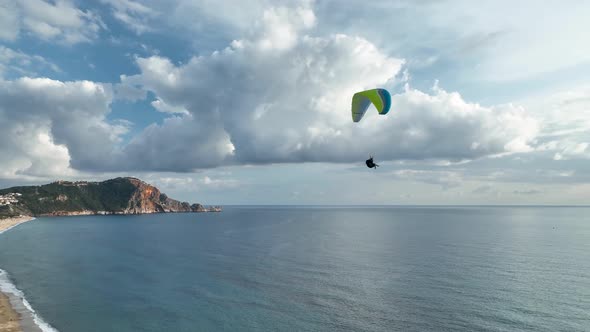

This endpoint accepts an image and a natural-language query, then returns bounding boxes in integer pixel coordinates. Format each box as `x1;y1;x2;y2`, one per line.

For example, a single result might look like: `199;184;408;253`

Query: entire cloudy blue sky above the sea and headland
0;0;590;204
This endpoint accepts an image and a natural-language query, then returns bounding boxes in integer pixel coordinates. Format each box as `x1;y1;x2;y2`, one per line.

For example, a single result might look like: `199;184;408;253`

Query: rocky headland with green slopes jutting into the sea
0;177;221;217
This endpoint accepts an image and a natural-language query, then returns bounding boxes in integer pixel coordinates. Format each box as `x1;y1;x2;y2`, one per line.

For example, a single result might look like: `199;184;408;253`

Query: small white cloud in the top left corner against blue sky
0;0;105;44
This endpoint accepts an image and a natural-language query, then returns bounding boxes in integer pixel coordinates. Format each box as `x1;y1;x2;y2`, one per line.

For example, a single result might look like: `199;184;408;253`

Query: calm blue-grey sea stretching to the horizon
0;207;590;332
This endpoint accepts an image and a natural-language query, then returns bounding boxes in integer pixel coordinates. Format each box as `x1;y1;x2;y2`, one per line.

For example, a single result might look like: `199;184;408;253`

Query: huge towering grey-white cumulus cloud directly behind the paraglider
118;3;538;169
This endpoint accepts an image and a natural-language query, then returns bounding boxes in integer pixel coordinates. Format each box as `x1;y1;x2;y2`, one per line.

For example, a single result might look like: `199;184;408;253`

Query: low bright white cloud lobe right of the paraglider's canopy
386;87;539;160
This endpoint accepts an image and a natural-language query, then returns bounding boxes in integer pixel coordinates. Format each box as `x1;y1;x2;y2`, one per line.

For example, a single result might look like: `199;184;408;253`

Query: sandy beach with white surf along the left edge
0;216;56;332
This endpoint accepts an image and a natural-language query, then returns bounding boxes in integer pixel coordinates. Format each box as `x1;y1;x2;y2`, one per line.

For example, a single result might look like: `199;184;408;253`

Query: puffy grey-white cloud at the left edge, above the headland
0;77;128;176
